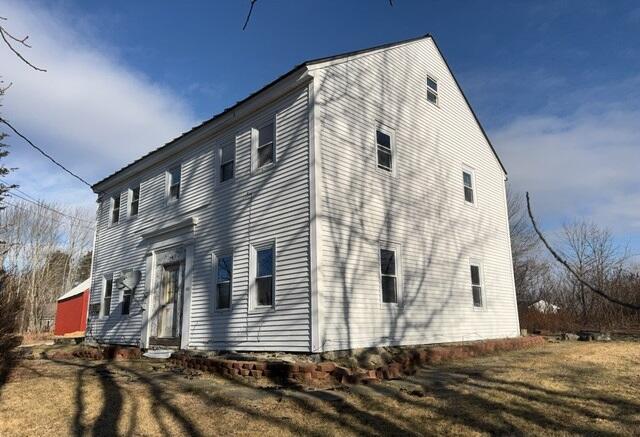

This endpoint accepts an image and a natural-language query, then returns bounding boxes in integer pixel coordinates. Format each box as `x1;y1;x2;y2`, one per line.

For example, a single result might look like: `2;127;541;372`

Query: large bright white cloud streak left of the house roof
0;1;196;203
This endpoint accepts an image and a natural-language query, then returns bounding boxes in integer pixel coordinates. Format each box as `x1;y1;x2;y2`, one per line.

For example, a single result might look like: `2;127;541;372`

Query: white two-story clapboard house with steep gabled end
87;35;519;352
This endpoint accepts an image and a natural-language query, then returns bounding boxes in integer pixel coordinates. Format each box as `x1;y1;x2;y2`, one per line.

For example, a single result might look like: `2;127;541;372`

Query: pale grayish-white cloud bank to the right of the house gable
492;105;640;237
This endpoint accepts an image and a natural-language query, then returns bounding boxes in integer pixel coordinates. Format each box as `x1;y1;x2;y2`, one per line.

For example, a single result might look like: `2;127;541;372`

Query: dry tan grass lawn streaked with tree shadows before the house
0;342;640;436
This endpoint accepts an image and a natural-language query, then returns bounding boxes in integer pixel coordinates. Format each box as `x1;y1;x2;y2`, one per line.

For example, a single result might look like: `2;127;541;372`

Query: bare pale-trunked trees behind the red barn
0;198;93;332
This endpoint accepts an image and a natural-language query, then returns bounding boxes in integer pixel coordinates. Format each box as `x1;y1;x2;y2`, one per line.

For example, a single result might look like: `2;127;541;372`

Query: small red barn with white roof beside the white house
54;278;91;336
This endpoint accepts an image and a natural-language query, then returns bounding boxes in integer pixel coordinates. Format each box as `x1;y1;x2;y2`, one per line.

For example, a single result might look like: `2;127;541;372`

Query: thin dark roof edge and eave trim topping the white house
92;33;507;193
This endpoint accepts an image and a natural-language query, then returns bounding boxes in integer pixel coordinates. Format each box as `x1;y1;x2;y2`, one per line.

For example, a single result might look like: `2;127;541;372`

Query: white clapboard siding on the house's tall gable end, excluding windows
312;38;518;350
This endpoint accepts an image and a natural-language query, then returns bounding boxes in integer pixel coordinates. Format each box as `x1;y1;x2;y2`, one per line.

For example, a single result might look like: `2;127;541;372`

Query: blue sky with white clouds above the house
0;0;640;252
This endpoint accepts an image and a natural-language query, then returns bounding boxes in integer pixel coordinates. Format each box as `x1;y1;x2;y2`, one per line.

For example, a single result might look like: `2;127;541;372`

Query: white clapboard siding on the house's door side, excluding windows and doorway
89;85;310;351
